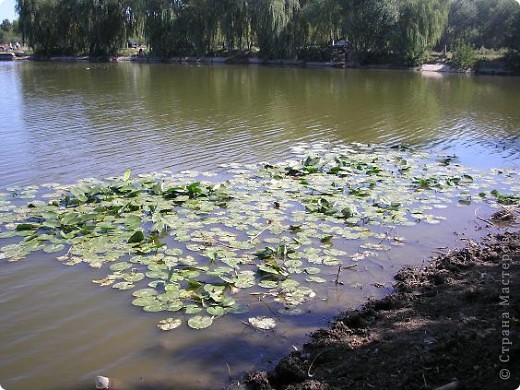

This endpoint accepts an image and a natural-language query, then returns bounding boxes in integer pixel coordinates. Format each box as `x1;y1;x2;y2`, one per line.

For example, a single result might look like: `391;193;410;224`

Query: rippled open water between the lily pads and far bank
0;62;520;187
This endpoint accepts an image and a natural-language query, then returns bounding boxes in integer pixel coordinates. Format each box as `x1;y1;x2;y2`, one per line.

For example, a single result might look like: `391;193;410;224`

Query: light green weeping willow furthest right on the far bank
396;0;449;65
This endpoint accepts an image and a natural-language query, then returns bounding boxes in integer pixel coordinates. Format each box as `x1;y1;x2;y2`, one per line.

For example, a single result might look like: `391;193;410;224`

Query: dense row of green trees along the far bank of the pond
17;0;520;65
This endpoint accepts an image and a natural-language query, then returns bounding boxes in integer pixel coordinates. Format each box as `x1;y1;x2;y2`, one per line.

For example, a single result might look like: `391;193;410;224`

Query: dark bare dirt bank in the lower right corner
248;227;520;390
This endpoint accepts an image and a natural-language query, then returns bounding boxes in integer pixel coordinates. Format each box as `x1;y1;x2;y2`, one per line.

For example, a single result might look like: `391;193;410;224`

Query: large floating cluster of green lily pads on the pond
0;144;519;330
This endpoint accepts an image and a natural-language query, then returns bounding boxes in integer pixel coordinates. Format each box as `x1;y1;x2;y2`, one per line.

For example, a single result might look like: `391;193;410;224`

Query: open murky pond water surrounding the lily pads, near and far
0;62;520;390
